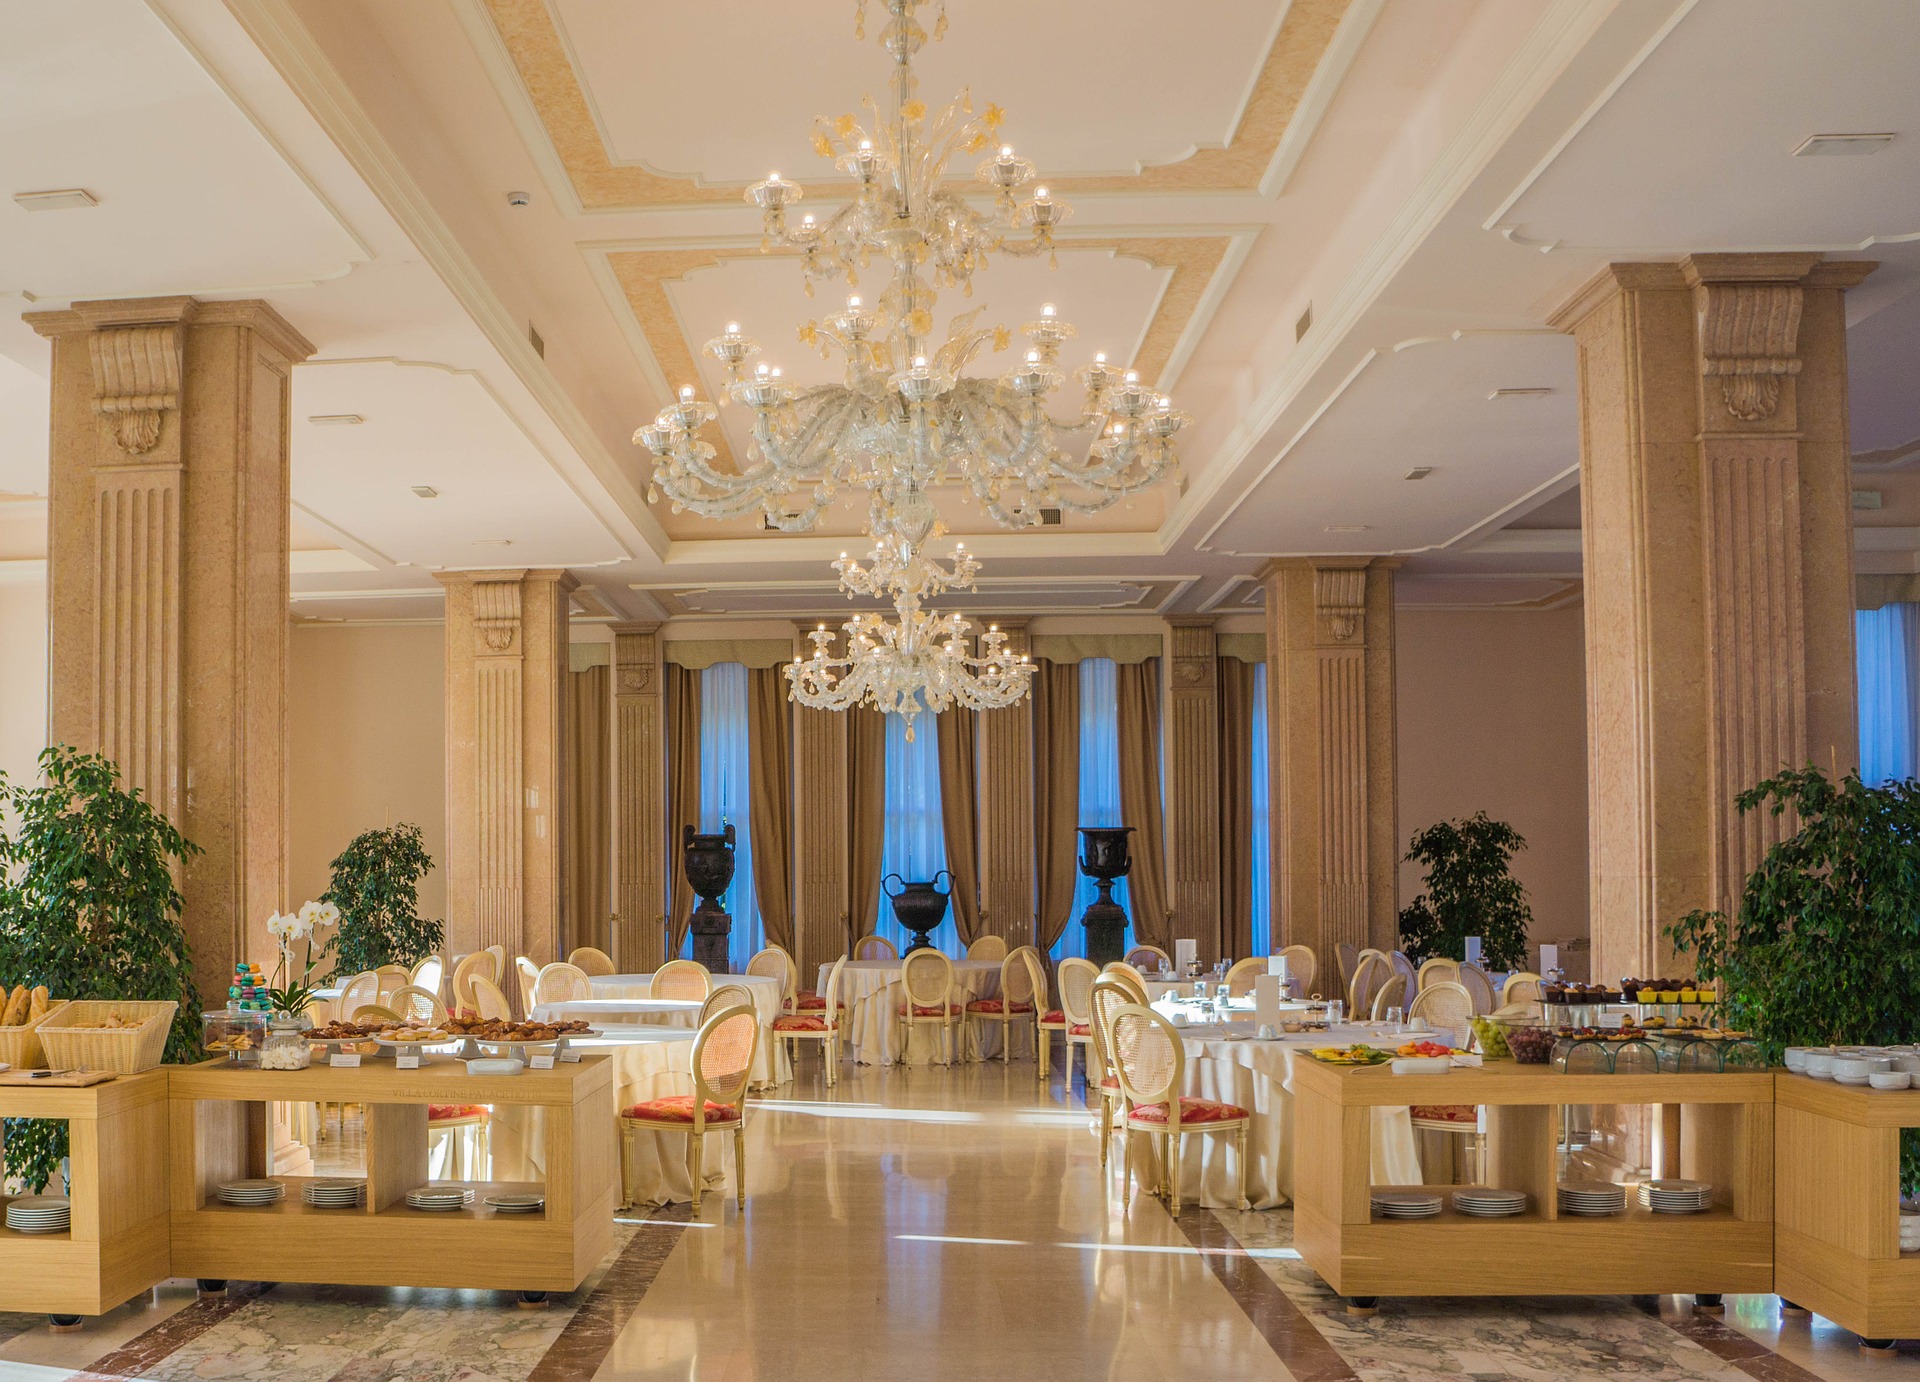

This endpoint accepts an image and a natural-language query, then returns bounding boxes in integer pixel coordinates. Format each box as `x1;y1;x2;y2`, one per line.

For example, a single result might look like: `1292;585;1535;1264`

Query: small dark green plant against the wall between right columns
1400;812;1534;969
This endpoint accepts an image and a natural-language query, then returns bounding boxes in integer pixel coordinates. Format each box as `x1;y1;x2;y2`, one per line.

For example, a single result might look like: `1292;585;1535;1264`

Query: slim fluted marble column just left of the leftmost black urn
612;624;670;973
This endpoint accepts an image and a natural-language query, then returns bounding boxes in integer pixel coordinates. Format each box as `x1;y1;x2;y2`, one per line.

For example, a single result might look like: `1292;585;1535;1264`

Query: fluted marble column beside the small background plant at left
438;570;578;967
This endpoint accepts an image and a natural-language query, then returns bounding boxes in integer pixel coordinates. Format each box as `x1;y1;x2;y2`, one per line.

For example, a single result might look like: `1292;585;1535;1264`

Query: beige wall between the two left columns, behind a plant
286;624;447;919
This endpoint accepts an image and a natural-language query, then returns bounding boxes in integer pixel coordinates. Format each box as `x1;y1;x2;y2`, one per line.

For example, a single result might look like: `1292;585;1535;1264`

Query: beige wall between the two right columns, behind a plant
1396;605;1588;959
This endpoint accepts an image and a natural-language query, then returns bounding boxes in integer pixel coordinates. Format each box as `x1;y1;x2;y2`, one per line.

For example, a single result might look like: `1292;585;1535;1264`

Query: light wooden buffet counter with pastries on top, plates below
171;1056;620;1294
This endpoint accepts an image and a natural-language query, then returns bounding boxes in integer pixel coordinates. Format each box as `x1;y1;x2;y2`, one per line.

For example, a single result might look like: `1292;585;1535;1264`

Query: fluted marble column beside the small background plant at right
1261;557;1400;978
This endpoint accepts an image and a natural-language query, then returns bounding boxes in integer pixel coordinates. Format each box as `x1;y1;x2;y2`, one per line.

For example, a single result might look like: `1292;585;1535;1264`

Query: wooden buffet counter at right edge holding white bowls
1774;1071;1920;1344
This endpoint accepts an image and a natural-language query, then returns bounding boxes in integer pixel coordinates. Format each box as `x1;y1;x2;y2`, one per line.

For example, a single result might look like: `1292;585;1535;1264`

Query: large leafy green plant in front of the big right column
1667;766;1920;1194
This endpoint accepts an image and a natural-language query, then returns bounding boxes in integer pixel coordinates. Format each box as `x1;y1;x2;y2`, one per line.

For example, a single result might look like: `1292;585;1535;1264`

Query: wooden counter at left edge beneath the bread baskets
0;1069;169;1324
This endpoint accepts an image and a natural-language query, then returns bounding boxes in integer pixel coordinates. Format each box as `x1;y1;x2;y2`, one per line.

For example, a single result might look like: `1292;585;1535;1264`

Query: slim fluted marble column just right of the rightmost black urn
1165;618;1223;964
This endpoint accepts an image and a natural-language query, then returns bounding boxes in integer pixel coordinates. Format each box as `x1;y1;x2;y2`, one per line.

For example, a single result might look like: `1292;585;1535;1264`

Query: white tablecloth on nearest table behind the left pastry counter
490;1025;733;1207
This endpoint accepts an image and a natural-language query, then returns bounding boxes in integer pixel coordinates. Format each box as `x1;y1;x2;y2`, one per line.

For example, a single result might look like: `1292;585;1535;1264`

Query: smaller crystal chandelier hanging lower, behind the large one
787;489;1033;739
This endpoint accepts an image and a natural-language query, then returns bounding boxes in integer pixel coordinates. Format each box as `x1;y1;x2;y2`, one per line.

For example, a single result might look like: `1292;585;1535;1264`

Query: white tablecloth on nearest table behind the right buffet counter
1131;1021;1421;1209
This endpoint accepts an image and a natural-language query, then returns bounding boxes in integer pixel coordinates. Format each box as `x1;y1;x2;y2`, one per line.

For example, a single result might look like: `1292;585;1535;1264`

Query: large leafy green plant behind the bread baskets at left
0;745;200;1190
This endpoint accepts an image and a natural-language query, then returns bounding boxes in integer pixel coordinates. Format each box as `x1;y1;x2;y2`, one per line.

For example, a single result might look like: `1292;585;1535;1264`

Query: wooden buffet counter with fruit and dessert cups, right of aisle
1294;1060;1774;1307
